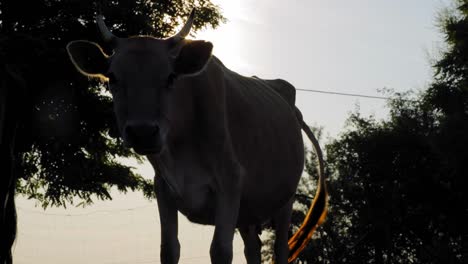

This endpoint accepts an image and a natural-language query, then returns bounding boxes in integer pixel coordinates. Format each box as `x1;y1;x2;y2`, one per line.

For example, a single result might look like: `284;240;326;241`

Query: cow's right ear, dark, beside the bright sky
174;40;213;75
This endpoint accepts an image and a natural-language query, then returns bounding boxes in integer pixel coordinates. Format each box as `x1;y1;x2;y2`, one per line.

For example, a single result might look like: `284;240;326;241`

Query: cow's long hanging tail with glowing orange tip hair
288;108;328;263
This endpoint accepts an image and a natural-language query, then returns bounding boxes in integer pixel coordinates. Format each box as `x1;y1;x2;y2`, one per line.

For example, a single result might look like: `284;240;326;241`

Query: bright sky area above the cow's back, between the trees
198;0;448;137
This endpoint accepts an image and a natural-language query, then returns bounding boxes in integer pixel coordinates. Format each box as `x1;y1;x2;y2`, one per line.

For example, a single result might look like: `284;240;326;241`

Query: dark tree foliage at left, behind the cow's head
0;0;224;207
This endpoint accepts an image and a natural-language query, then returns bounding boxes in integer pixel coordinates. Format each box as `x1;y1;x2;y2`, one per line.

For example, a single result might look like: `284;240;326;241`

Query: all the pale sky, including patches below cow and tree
14;0;449;264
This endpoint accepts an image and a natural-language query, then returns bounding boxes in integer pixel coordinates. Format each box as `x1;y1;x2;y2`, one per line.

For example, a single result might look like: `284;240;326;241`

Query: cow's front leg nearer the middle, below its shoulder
210;158;243;264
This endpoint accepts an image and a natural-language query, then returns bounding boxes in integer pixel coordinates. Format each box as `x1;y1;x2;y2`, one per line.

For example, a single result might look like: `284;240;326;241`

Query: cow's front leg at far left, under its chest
154;175;180;264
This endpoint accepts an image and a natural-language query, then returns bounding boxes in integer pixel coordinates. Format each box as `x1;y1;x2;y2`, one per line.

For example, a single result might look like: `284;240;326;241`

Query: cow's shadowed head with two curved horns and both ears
67;11;213;154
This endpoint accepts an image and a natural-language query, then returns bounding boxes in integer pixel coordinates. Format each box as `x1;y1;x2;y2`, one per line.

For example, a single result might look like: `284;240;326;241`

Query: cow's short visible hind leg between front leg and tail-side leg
239;225;262;264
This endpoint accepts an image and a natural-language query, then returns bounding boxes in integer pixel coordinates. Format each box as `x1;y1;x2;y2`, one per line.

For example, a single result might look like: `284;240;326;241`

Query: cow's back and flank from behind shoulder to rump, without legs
214;58;304;225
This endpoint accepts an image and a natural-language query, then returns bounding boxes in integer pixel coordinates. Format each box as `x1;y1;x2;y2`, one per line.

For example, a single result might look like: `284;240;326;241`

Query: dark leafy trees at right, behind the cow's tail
288;0;468;264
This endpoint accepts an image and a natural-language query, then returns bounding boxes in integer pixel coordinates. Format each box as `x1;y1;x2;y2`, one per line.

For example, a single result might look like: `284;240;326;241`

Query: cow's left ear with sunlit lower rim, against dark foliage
67;40;109;79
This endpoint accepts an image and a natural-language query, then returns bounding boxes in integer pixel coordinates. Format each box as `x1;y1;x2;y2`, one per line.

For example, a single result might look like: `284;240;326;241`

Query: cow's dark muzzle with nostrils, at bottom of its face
123;120;162;155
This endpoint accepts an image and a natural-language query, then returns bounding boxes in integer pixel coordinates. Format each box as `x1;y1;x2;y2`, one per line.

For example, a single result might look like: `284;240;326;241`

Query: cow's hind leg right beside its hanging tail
273;199;294;264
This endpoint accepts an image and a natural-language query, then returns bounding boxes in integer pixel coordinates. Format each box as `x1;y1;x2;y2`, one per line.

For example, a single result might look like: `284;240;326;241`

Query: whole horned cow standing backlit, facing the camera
67;10;327;264
